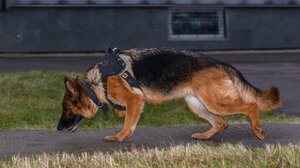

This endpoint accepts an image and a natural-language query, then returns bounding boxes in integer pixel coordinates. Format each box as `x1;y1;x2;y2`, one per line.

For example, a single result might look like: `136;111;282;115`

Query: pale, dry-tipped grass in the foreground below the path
0;143;300;168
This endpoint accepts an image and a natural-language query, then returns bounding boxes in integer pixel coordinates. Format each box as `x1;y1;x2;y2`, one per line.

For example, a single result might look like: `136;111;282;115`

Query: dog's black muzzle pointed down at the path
57;115;83;132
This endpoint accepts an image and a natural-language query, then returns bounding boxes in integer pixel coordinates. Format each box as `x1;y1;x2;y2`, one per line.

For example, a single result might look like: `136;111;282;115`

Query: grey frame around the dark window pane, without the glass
168;8;225;41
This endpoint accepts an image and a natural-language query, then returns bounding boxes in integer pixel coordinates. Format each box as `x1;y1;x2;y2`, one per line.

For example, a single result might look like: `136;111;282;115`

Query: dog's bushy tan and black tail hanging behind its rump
219;63;281;111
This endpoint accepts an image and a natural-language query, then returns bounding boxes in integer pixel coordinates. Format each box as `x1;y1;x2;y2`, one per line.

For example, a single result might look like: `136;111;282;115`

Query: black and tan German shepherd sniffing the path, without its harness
58;48;281;141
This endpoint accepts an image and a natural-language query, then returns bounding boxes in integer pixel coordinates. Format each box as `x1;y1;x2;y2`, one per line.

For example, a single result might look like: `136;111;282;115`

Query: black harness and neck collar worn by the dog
82;48;140;114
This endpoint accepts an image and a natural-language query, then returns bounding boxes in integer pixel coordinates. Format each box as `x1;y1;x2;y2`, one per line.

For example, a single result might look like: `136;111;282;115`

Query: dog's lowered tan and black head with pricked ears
57;76;98;131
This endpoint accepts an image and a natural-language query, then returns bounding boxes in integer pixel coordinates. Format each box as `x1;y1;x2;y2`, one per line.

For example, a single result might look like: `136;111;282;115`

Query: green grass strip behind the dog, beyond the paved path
0;72;300;130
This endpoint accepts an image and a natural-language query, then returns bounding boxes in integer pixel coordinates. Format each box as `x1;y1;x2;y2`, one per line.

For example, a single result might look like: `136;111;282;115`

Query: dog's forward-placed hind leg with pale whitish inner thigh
185;95;227;139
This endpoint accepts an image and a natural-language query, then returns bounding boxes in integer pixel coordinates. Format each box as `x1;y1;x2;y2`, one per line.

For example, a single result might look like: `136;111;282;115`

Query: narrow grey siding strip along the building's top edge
6;0;300;6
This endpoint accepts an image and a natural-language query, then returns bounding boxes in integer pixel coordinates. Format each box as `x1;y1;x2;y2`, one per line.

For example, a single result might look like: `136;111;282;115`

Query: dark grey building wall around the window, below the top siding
0;6;300;52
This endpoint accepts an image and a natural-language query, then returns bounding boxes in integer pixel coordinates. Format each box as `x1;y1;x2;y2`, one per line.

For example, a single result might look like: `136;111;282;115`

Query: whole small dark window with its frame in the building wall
169;9;224;40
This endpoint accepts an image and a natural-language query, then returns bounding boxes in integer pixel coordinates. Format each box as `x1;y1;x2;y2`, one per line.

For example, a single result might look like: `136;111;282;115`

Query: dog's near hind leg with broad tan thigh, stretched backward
191;68;264;139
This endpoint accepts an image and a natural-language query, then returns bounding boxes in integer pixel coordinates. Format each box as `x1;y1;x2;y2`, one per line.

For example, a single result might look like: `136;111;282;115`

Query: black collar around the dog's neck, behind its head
81;80;109;114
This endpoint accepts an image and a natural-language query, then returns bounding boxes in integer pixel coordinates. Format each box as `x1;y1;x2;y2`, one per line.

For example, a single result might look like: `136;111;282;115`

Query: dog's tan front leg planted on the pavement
104;95;144;142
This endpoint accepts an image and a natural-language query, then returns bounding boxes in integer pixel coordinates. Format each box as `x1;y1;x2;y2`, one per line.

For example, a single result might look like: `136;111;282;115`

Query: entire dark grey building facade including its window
0;0;300;52
